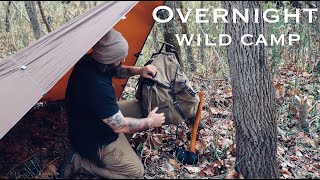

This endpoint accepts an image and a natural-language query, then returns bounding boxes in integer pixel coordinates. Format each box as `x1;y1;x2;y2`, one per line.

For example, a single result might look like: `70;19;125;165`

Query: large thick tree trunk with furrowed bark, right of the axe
222;1;278;179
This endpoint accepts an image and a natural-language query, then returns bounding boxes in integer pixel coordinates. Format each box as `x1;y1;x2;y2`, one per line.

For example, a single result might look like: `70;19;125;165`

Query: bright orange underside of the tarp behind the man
40;1;164;101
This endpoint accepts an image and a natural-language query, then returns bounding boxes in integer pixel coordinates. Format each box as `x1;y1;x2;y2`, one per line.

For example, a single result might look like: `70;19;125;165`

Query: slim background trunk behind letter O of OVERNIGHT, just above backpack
161;1;185;70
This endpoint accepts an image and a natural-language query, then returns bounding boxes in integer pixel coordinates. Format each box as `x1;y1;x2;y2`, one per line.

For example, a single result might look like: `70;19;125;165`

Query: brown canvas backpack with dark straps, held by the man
136;43;199;125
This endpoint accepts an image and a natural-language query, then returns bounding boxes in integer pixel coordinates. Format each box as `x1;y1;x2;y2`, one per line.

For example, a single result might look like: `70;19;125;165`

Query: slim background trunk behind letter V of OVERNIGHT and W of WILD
177;1;196;72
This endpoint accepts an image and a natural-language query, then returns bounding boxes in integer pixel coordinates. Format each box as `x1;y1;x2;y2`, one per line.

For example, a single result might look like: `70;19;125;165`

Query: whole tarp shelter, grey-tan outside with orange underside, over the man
0;1;163;138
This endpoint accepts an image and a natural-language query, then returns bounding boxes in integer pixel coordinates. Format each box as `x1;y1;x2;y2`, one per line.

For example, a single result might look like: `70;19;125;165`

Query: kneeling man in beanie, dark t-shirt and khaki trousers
60;29;165;179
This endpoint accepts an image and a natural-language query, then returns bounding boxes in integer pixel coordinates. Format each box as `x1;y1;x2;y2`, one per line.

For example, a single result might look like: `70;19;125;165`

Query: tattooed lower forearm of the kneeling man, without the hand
103;111;149;133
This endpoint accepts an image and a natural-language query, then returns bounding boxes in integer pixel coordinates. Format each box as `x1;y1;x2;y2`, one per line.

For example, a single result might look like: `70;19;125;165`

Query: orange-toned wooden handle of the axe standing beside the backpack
189;91;204;153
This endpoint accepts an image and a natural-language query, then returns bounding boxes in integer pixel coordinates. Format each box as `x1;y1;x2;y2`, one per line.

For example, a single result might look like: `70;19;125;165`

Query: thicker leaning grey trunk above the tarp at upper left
24;1;41;39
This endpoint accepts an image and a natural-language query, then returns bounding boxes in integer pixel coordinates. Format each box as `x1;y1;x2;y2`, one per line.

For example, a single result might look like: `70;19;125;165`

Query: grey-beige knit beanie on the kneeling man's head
92;28;129;64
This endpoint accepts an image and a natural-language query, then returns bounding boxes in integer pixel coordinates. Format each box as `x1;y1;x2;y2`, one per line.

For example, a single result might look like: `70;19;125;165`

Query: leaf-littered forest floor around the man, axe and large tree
0;65;320;179
